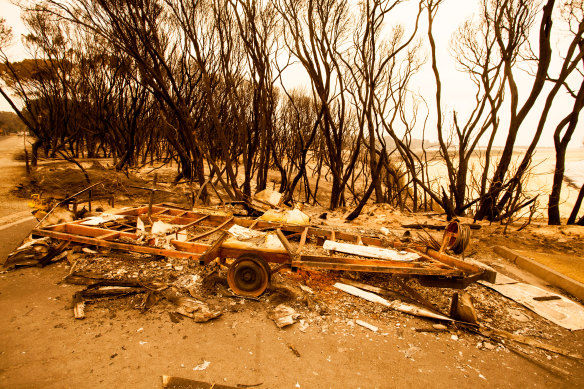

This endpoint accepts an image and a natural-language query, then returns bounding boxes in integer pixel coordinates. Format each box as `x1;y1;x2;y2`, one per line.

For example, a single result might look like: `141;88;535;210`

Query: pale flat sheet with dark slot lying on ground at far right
479;274;584;331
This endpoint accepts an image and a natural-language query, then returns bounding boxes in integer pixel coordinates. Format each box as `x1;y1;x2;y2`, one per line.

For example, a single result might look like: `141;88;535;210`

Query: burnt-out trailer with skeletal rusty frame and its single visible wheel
33;204;494;296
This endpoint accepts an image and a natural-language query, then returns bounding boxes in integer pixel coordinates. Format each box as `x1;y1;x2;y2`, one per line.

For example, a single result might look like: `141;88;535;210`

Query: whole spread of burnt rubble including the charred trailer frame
5;194;584;378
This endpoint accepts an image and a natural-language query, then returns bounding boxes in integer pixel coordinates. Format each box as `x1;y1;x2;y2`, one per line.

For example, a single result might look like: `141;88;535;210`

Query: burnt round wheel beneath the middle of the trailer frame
227;254;271;297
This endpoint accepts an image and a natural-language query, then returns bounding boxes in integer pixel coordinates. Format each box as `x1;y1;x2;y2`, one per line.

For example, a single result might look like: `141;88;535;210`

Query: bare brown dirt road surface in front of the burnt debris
0;134;584;388
